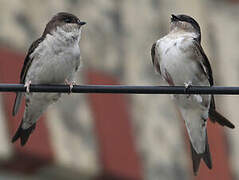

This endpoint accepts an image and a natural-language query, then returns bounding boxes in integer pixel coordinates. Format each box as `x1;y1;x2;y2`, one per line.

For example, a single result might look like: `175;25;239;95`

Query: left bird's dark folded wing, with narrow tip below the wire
12;37;44;116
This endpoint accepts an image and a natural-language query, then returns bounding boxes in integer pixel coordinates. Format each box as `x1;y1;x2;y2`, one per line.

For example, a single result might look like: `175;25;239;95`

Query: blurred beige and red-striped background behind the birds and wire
0;0;239;180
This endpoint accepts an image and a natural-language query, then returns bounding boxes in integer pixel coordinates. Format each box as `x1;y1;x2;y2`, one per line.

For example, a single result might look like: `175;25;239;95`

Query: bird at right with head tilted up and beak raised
151;14;235;175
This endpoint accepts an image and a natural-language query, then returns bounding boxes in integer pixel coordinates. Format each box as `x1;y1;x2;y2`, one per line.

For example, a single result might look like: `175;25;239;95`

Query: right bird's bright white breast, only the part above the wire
157;35;202;85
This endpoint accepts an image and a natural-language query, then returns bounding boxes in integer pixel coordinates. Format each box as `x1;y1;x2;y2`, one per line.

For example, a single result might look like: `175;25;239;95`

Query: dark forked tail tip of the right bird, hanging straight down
190;134;212;176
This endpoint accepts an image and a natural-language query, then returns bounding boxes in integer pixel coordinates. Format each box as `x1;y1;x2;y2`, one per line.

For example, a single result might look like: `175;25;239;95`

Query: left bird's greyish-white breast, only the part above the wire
26;29;80;83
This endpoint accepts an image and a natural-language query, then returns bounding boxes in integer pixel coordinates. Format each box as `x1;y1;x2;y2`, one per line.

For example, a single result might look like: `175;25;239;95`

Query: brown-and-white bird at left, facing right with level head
12;12;86;146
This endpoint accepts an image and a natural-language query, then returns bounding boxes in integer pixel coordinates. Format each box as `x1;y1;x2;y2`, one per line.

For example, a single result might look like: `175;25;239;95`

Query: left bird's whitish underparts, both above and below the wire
22;27;81;129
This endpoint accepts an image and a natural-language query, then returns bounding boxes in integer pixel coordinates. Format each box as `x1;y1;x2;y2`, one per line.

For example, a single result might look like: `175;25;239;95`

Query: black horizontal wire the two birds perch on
0;84;239;95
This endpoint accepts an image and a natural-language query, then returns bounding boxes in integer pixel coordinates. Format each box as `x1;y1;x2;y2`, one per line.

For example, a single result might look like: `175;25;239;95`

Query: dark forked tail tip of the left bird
12;121;36;146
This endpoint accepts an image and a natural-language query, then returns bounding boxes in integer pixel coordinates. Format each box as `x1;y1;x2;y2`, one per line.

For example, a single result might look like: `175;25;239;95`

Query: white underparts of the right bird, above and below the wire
156;33;211;154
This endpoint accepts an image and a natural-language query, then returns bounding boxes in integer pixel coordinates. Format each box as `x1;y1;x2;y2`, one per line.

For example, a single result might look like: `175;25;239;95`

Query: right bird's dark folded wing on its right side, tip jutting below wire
194;40;235;128
